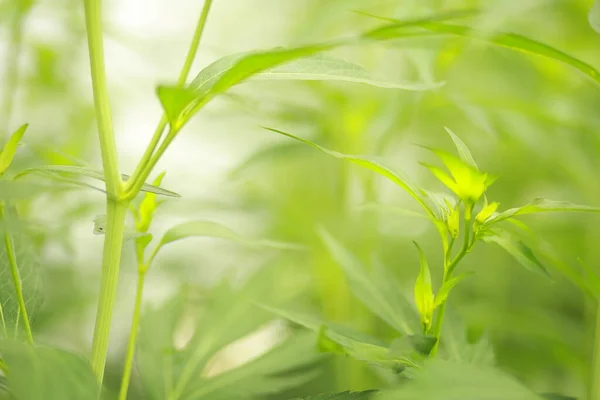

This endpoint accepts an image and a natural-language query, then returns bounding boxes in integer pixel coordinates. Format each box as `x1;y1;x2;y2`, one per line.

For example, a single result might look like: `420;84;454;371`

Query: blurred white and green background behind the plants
0;0;600;399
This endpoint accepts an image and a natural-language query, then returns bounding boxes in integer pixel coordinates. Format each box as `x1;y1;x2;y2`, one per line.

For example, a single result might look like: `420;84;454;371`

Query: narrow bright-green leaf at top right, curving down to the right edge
365;17;600;84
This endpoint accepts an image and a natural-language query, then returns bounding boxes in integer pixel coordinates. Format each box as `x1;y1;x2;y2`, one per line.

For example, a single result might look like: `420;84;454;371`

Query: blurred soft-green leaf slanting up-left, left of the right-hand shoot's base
319;229;418;334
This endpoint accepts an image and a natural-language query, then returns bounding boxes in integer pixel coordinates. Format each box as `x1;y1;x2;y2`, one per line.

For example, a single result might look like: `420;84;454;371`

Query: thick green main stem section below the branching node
91;199;128;382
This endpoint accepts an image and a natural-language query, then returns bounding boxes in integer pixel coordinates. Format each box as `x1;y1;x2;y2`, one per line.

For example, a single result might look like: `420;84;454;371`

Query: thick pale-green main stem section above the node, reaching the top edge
84;0;122;198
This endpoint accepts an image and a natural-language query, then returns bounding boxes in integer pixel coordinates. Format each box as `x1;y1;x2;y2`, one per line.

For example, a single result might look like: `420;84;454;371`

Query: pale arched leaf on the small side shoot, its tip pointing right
151;220;304;259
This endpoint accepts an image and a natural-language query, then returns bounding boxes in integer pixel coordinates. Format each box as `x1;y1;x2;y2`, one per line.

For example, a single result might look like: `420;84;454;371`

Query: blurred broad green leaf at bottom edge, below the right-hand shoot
377;360;541;400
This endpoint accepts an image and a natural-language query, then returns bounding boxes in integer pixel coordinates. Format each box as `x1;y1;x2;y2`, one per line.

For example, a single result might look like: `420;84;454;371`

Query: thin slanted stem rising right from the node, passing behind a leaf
127;0;212;192
